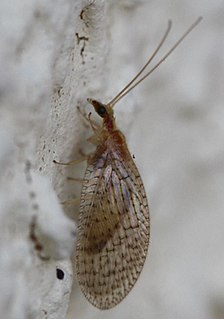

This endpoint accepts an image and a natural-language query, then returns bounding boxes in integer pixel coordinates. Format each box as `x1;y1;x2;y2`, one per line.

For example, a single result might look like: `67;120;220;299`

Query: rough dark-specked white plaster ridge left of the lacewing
0;0;106;319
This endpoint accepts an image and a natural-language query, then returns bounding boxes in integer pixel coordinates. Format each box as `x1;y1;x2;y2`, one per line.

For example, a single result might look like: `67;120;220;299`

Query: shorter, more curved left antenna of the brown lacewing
107;20;172;106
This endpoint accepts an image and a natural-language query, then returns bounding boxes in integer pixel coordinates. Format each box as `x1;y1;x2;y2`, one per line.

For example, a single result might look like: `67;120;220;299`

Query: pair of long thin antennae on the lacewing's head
107;17;202;107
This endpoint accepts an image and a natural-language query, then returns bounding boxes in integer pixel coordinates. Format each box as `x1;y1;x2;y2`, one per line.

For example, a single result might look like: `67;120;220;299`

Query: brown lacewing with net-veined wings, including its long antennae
76;17;202;309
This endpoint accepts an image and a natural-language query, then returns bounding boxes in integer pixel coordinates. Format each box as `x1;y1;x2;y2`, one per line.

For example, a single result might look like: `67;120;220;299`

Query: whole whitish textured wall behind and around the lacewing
0;0;224;319
